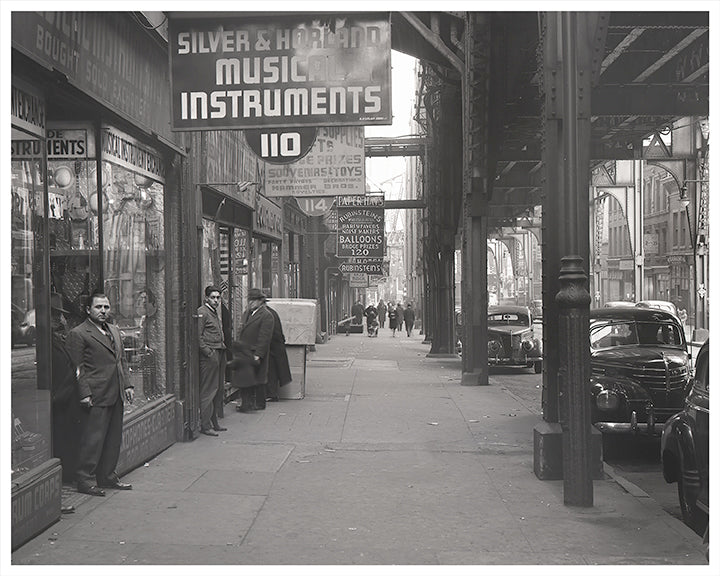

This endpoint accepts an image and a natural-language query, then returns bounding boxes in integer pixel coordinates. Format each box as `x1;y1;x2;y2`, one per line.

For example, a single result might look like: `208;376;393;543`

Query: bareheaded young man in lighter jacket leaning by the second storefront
197;285;227;436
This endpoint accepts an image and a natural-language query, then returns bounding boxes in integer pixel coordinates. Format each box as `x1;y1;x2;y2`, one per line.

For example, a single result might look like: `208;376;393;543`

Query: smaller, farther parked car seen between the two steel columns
488;306;542;374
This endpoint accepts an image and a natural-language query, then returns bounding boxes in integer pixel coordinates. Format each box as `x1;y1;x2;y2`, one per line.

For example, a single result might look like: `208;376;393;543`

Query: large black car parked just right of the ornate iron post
590;308;690;436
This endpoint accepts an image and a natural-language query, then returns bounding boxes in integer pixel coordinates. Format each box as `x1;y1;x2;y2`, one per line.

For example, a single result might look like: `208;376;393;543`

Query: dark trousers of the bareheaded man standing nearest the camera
76;399;123;484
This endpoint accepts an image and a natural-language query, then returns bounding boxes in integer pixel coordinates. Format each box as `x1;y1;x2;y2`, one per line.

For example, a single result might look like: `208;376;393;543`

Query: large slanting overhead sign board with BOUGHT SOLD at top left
12;11;173;139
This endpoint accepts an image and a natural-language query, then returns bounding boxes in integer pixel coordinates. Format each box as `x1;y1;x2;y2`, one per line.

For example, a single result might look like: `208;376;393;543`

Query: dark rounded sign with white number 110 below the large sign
243;126;318;164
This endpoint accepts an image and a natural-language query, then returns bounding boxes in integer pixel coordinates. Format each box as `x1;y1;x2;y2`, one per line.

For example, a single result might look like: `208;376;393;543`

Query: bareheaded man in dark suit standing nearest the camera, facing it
65;292;135;496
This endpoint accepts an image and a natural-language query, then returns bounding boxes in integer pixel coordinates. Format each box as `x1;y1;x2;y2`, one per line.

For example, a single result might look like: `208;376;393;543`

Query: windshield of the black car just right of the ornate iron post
590;320;683;349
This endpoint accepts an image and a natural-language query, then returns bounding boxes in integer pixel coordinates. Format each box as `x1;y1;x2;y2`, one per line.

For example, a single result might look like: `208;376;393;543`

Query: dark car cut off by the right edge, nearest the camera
660;341;710;535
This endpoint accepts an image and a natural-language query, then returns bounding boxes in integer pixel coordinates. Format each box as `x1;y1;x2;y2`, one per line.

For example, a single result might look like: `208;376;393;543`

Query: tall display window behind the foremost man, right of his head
102;161;167;411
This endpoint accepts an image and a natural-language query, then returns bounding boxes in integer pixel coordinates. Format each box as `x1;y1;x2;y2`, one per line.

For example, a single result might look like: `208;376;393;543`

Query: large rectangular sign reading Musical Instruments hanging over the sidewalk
169;12;392;130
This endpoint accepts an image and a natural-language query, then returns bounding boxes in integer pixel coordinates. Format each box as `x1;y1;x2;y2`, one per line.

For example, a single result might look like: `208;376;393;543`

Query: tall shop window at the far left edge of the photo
10;126;51;479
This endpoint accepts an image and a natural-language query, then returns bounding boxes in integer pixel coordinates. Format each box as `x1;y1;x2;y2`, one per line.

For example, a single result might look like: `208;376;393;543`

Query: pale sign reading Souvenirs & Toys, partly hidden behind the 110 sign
265;126;365;198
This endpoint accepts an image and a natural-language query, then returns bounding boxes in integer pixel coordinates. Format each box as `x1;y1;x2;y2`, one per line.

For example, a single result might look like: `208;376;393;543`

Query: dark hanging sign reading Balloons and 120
337;196;385;259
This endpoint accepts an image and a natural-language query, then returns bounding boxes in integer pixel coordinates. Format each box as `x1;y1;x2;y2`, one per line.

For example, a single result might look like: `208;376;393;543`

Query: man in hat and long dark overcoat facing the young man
240;288;275;412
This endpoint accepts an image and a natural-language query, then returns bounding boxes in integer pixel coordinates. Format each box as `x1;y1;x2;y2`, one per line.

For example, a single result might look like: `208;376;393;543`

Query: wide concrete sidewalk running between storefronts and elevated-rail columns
12;329;707;573
